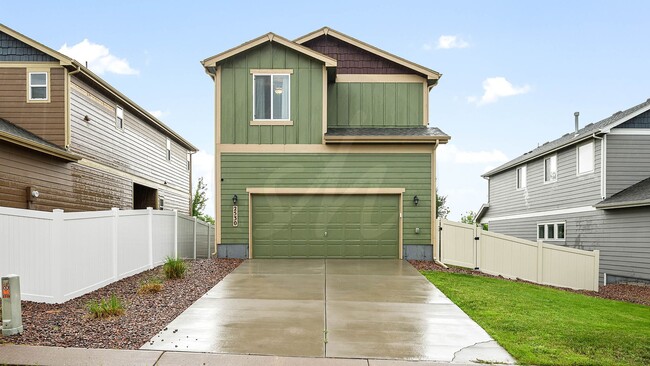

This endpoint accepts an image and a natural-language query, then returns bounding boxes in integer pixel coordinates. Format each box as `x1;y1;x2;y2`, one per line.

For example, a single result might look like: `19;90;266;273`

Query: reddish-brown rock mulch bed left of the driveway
0;259;242;349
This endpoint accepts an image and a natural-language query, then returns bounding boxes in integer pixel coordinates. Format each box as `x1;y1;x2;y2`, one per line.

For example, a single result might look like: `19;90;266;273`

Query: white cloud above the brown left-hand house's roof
59;39;138;75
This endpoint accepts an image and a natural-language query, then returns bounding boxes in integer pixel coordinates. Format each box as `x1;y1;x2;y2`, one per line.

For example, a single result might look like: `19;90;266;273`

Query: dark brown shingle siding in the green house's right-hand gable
303;35;422;76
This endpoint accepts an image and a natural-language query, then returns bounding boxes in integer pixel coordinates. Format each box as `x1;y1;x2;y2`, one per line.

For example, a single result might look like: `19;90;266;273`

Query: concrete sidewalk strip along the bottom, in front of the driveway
0;345;502;366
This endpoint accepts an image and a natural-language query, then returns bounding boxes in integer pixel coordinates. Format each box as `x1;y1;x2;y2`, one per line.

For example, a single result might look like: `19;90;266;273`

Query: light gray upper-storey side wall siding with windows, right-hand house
486;140;601;218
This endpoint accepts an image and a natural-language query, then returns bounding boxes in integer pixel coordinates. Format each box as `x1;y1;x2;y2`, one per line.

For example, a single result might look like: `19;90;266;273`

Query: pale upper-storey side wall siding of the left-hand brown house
70;77;190;213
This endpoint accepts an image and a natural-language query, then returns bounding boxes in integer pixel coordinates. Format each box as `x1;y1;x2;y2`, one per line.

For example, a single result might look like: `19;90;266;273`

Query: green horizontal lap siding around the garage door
220;153;432;250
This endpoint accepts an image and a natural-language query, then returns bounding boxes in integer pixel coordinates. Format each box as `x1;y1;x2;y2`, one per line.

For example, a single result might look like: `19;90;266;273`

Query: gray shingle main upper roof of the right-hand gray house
482;99;650;177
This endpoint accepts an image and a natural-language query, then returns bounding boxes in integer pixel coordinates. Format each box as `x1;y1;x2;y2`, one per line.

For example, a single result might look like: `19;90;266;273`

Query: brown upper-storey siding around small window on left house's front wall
0;66;65;147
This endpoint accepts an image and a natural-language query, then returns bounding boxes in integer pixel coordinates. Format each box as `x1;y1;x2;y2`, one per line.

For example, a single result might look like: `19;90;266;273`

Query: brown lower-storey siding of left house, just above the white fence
0;141;133;211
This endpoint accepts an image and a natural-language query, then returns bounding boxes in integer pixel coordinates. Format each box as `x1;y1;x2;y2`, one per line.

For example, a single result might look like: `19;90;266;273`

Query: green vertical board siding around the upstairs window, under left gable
220;42;324;144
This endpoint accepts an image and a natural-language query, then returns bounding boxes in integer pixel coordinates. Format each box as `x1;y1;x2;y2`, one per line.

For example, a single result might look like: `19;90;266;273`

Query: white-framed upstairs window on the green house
253;74;291;120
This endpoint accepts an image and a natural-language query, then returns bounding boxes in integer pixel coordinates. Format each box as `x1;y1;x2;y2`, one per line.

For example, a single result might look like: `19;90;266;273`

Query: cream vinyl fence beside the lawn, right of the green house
438;219;600;291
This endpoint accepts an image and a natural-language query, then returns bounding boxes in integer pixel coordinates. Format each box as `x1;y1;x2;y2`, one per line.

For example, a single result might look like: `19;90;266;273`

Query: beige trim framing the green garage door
246;187;406;259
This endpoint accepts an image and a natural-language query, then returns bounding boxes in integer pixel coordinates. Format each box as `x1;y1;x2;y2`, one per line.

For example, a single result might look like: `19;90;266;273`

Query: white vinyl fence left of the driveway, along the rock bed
0;207;214;303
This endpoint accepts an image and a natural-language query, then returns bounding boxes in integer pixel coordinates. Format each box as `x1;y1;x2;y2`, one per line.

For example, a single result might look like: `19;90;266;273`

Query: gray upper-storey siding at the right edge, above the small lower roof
606;134;650;197
